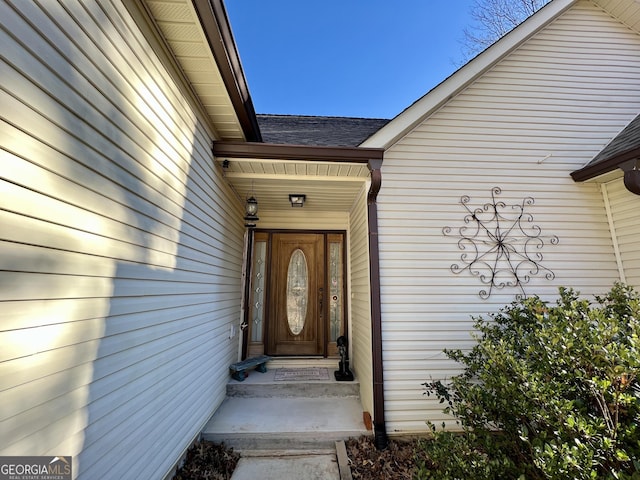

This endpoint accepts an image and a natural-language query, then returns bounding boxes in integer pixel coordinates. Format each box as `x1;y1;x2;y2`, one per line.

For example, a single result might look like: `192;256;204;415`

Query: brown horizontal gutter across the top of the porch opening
213;142;384;164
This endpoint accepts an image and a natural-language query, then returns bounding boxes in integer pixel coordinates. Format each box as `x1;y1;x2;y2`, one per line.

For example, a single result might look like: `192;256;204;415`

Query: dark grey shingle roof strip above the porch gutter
257;115;389;147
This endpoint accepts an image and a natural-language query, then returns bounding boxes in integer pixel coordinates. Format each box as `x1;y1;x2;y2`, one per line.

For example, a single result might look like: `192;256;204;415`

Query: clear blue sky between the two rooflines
225;0;473;118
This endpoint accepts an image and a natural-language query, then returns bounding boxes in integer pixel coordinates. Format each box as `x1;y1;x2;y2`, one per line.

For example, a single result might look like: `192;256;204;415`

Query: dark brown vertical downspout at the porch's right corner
367;160;389;450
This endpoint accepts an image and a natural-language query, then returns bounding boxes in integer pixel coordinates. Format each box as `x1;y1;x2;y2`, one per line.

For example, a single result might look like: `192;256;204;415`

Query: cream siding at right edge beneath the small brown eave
605;179;640;289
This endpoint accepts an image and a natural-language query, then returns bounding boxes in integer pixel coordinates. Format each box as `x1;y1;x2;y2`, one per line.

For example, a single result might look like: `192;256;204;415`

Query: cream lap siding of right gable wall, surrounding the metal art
379;2;640;434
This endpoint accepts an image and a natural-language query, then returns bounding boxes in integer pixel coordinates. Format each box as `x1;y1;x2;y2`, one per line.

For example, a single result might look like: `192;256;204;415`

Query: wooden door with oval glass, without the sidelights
266;233;326;355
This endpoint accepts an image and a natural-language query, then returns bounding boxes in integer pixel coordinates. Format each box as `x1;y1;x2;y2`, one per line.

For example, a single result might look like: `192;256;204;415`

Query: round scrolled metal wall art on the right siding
442;187;559;299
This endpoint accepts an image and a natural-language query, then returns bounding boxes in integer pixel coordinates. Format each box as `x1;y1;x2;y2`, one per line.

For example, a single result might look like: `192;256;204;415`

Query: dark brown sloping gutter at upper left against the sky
192;0;262;142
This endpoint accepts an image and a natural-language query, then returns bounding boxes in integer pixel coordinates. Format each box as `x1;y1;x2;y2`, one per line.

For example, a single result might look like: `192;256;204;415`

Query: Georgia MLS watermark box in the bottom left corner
0;456;71;480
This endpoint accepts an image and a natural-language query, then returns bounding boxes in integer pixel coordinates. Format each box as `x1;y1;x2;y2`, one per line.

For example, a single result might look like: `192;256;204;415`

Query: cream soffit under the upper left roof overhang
144;0;245;140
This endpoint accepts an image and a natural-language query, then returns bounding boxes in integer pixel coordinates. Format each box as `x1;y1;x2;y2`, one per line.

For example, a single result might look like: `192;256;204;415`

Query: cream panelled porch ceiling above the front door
216;158;369;212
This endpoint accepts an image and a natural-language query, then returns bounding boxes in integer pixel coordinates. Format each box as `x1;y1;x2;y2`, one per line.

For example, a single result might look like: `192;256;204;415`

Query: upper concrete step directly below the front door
227;363;360;398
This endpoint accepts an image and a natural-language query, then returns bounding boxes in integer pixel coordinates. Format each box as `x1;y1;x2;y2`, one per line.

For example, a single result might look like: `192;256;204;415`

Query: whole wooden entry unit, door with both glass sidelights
243;230;347;358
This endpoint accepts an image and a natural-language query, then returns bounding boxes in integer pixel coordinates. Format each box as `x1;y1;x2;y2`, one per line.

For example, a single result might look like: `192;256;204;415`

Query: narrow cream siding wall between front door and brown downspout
348;188;373;416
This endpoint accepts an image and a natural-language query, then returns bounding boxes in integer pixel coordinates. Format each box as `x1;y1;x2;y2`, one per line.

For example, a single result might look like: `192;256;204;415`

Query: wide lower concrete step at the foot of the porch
202;397;371;451
